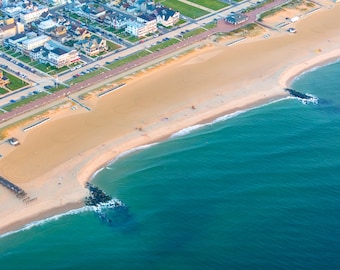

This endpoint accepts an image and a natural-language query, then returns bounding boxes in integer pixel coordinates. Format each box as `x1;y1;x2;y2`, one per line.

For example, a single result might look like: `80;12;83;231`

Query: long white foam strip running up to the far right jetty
170;97;289;138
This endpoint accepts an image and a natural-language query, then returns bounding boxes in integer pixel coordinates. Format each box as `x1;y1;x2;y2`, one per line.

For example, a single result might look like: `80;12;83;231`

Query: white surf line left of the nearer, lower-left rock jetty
0;206;95;238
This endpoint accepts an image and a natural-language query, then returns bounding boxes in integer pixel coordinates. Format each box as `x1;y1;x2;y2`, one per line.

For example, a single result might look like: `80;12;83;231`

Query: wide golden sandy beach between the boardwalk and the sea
0;2;340;234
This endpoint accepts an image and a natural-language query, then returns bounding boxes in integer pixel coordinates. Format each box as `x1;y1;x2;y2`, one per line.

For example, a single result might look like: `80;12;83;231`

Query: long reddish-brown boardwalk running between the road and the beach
0;0;288;123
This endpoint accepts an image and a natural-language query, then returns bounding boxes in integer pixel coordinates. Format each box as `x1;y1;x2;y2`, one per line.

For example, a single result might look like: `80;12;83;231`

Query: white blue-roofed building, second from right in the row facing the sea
125;15;158;37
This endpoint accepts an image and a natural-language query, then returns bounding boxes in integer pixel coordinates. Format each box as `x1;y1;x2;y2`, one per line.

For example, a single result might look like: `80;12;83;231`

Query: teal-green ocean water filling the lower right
0;63;340;270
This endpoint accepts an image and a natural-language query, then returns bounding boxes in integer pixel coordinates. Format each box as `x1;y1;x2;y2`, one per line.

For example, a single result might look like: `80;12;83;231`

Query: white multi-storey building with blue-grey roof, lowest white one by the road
47;48;80;68
